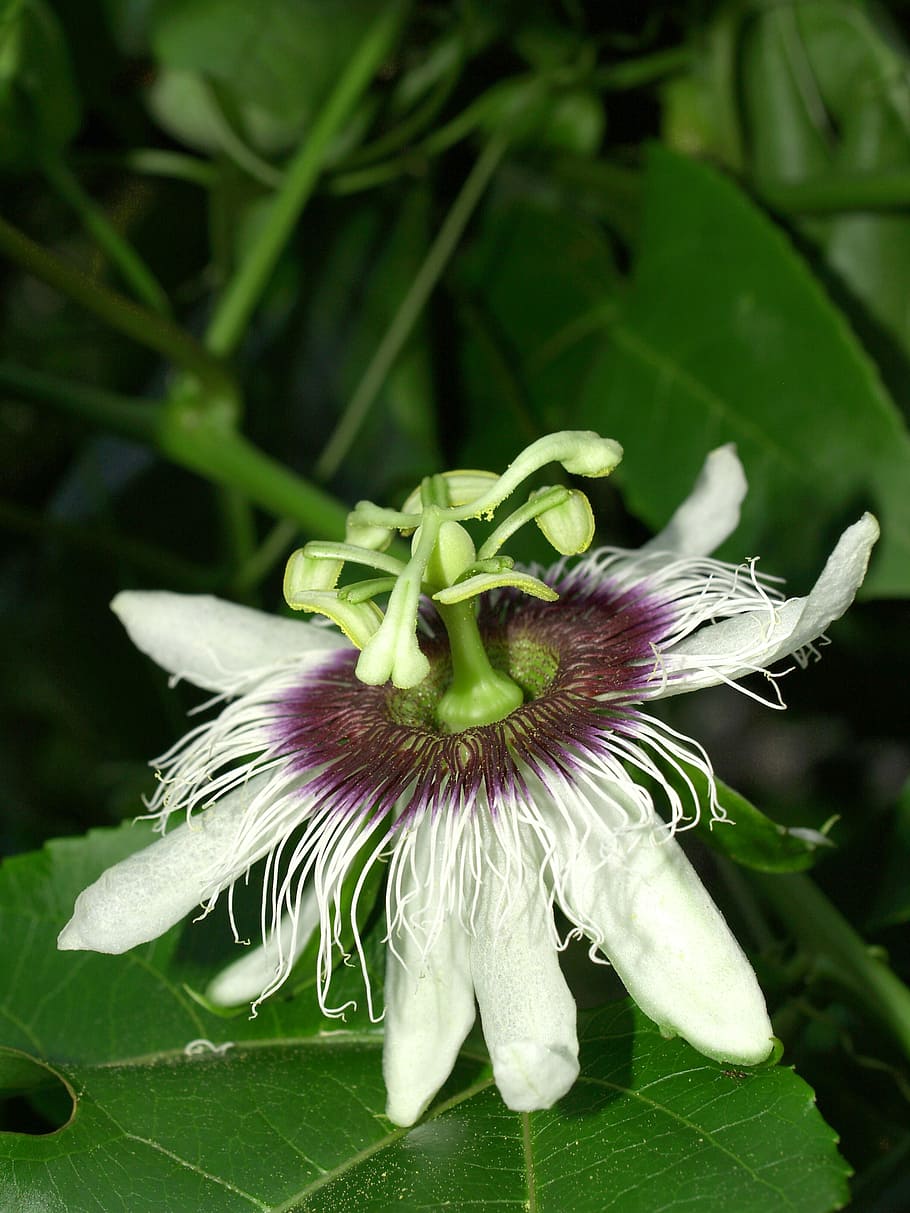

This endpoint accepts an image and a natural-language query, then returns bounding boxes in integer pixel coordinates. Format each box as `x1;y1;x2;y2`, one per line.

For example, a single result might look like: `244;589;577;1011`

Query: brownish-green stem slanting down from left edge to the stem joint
0;218;237;400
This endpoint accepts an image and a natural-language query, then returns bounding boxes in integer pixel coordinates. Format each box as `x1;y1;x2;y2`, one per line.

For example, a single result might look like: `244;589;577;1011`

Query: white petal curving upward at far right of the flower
652;514;878;699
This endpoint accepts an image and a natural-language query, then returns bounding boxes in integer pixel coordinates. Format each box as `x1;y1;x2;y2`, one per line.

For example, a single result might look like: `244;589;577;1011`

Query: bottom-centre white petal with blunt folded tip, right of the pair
471;827;579;1112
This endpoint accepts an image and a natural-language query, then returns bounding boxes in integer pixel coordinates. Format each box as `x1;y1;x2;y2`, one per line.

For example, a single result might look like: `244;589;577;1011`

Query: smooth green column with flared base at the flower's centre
436;602;524;733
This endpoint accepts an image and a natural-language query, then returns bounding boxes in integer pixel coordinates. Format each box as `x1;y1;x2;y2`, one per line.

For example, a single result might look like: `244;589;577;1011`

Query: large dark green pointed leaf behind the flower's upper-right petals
578;148;910;596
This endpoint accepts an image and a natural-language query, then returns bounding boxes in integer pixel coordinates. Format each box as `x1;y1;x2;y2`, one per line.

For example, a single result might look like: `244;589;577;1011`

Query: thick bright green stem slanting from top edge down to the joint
205;2;403;355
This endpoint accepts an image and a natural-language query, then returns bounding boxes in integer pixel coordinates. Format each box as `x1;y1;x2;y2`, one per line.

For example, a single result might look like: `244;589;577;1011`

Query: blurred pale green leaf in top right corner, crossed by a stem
741;0;910;403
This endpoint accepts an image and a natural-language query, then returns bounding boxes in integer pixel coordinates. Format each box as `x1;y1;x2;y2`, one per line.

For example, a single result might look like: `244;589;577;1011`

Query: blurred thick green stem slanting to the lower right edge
749;872;910;1057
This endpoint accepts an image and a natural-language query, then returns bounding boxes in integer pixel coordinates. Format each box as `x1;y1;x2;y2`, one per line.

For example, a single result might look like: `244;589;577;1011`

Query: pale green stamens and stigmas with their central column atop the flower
310;431;622;718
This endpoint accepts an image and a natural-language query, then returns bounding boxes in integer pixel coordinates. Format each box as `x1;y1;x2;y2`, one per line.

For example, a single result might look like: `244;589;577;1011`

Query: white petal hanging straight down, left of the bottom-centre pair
382;818;474;1124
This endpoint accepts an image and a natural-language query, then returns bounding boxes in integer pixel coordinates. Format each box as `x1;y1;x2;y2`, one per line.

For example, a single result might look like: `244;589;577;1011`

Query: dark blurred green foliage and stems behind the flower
0;0;910;1209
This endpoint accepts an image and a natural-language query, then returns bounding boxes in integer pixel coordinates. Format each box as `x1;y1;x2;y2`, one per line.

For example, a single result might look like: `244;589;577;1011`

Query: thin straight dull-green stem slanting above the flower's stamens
314;136;507;480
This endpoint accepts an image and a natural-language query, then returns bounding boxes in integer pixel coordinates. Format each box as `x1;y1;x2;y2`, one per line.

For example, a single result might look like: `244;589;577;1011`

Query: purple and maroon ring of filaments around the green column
272;577;673;824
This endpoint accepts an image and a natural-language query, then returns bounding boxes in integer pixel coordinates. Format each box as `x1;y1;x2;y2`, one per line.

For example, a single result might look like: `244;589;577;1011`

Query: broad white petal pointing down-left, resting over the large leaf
57;780;274;955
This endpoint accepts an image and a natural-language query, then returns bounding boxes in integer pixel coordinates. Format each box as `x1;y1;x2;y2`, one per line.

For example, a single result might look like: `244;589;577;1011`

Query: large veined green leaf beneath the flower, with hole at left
0;826;846;1213
